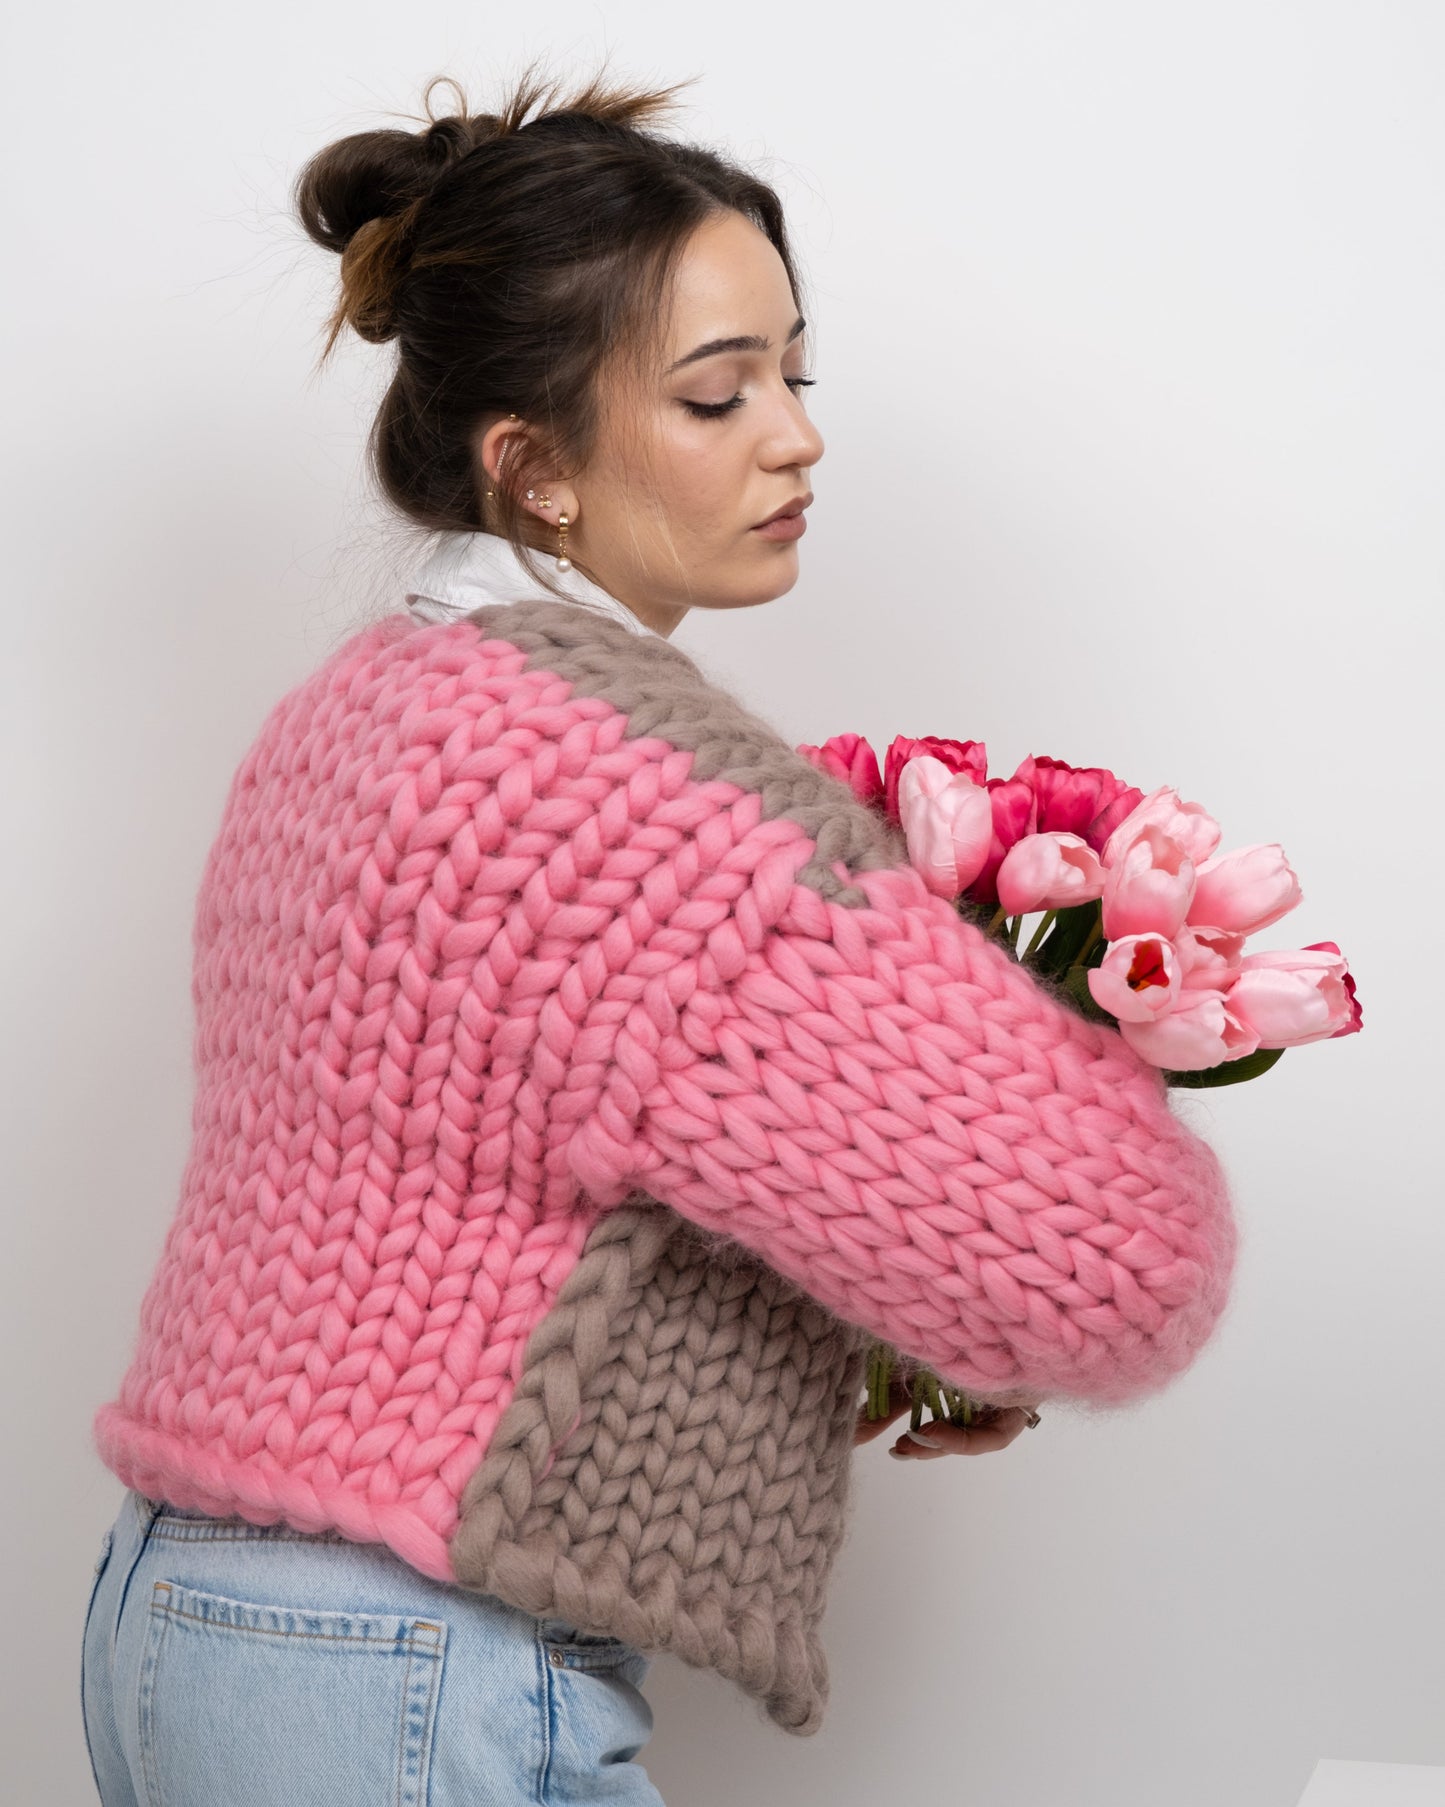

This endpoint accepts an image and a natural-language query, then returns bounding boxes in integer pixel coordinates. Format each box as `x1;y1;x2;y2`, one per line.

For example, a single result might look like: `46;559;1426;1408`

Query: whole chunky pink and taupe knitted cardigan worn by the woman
96;600;1235;1733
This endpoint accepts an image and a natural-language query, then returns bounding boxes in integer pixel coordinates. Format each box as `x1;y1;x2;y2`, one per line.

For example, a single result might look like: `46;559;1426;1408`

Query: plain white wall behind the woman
0;0;1445;1807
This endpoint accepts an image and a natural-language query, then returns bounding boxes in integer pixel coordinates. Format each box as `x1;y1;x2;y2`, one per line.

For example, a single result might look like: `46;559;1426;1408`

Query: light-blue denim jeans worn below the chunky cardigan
81;1493;661;1807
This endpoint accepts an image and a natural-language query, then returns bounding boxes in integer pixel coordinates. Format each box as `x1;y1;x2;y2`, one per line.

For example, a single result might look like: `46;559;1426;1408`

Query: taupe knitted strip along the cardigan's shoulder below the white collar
466;598;909;905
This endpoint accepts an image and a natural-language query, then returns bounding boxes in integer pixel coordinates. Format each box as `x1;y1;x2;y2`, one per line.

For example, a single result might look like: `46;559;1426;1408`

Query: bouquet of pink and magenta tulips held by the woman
798;734;1362;1429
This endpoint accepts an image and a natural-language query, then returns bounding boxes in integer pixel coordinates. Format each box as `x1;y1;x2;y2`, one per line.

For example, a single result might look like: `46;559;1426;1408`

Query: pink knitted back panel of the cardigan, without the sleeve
98;618;677;1574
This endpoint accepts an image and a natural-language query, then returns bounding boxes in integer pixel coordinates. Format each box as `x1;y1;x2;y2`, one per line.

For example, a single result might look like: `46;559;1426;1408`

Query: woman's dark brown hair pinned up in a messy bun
294;70;800;587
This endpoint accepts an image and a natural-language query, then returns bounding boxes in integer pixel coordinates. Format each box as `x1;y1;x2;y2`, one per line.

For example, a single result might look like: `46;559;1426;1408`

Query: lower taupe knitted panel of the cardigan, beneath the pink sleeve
452;1199;869;1735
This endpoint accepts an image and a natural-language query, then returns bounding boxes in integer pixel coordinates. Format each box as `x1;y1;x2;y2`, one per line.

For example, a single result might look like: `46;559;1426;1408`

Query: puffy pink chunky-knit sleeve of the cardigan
569;813;1237;1402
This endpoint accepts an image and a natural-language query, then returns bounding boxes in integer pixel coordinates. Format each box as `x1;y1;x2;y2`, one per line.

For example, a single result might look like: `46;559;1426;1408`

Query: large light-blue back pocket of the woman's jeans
139;1581;446;1807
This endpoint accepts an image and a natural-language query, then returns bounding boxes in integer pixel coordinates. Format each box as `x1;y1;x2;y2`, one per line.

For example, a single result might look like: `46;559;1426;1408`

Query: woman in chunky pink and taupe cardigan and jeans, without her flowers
83;66;1234;1807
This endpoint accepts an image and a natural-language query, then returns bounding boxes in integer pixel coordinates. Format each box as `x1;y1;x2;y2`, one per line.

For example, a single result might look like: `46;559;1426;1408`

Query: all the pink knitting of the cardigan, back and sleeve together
98;616;1234;1574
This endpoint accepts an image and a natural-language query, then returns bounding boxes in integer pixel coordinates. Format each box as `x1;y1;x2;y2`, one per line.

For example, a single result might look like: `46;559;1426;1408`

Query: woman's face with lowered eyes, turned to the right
574;213;824;634
